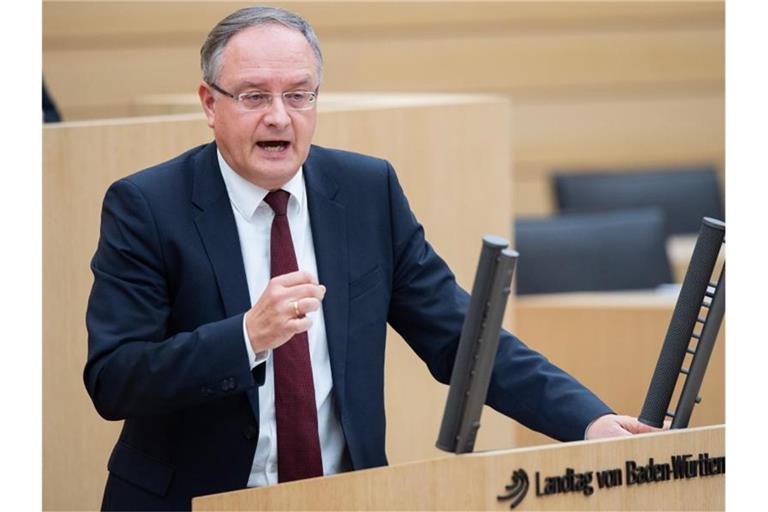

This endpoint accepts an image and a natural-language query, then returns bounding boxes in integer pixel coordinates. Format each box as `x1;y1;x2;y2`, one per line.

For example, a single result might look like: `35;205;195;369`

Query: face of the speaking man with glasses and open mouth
198;24;319;190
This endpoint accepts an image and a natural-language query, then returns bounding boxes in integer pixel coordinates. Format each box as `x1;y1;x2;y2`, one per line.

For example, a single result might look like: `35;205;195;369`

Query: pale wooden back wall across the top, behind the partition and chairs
43;1;725;215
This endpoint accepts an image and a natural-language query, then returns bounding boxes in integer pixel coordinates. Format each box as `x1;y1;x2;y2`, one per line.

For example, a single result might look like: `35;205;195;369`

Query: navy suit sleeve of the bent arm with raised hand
83;180;254;420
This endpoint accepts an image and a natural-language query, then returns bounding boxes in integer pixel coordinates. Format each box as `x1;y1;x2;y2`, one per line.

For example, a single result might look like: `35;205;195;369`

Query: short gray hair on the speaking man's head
200;7;323;85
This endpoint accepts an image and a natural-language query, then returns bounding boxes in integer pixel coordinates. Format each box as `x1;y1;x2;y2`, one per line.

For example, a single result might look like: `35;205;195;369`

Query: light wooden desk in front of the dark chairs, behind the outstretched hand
512;287;725;446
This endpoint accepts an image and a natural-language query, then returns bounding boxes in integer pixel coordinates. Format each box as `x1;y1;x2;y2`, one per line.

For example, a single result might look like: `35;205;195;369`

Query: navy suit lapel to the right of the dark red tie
304;147;349;407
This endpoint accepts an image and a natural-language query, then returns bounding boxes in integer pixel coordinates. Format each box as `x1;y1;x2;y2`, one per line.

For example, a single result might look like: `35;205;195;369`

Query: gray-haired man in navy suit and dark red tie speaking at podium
84;8;660;510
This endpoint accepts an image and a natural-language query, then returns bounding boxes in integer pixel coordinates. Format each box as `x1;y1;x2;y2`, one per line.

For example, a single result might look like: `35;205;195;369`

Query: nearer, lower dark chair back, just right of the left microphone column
515;209;672;295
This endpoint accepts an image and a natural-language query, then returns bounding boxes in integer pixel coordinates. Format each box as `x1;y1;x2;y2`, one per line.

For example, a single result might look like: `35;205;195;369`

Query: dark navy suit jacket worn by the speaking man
84;144;609;510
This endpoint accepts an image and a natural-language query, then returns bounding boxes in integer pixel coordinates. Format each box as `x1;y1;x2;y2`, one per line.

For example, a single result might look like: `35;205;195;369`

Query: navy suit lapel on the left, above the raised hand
192;144;259;419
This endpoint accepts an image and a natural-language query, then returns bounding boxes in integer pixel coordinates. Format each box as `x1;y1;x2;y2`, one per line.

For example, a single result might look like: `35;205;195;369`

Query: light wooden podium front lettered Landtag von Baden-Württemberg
192;425;725;511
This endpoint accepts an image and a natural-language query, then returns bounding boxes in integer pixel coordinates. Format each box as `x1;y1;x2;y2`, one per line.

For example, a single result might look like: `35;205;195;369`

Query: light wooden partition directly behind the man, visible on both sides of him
43;96;514;510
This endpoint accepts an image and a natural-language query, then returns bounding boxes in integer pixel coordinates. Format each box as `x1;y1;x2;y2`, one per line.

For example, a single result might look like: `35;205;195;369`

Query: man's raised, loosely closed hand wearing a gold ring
245;271;325;354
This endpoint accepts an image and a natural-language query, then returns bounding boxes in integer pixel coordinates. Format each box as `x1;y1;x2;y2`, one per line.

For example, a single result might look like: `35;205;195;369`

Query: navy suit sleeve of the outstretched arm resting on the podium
389;163;612;441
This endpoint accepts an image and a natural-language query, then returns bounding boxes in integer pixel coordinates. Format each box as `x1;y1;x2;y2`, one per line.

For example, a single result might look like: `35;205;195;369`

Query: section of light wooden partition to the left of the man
43;116;214;510
